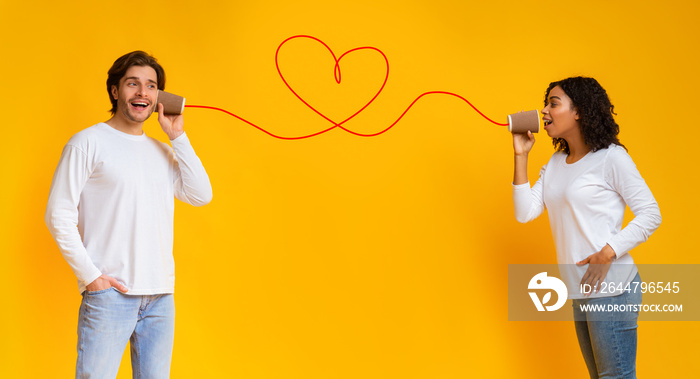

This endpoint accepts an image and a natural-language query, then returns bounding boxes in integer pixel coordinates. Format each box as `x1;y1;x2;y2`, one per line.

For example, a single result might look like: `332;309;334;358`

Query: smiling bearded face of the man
111;66;158;124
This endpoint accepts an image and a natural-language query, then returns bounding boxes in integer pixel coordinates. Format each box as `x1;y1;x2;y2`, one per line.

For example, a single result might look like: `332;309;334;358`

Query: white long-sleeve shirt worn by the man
45;123;212;295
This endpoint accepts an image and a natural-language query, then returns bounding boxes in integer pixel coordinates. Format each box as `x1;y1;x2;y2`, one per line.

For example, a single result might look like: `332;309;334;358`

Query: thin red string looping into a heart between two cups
185;35;508;140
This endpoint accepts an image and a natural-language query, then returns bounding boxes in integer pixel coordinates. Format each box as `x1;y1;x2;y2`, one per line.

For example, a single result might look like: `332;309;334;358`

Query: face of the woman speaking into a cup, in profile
542;86;581;140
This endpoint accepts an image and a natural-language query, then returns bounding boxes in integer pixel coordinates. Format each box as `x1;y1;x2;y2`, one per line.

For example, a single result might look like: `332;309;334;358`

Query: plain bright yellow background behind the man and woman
0;0;700;378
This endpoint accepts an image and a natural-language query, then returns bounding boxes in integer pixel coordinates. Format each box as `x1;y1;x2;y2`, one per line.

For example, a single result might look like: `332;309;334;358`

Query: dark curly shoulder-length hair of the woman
544;76;627;154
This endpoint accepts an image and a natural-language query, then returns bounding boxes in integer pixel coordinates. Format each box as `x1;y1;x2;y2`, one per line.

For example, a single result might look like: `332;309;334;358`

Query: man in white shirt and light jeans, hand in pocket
46;51;212;378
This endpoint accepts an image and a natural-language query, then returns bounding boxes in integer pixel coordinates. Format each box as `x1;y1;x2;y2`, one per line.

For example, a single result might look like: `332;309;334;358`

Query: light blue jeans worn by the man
75;288;175;378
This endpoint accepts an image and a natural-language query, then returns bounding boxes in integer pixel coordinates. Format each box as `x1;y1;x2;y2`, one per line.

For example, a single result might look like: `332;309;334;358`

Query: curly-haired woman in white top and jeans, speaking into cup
513;77;661;378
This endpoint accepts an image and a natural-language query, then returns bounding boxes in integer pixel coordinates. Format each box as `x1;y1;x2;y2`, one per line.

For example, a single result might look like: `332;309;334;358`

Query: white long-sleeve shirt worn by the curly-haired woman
513;144;661;299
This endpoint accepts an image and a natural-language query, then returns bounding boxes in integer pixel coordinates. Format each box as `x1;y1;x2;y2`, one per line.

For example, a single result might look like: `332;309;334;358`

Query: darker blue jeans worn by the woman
573;274;642;379
